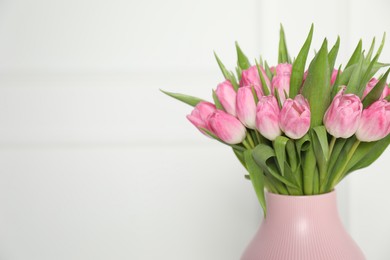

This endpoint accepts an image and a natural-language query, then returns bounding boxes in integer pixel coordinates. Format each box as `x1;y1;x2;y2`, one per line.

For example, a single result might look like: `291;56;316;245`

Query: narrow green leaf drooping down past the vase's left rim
244;150;267;217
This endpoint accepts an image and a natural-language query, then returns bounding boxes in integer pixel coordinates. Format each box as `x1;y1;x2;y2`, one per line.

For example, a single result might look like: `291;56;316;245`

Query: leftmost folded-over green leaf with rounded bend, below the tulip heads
252;144;299;188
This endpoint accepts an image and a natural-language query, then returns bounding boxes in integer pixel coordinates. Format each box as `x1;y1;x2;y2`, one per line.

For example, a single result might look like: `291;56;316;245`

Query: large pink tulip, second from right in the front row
324;88;363;138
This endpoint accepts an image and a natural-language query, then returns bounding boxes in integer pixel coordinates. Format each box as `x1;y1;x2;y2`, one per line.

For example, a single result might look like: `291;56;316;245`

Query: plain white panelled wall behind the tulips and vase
0;0;390;260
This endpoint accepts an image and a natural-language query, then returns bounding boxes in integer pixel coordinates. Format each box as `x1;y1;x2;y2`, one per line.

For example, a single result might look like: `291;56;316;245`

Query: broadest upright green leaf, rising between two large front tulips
302;39;331;127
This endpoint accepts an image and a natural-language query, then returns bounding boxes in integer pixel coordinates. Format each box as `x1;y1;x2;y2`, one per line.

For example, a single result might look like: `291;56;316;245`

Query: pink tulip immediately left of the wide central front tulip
256;96;282;141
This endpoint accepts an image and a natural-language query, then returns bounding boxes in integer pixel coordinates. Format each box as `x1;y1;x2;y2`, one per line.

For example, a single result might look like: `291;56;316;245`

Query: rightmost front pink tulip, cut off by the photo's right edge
356;99;390;142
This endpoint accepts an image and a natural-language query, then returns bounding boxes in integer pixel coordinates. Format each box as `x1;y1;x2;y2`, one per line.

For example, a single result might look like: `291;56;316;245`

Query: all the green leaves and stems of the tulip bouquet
163;25;390;214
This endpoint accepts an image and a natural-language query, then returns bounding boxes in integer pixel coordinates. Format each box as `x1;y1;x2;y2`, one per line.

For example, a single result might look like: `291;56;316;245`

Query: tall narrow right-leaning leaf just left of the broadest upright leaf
289;24;313;99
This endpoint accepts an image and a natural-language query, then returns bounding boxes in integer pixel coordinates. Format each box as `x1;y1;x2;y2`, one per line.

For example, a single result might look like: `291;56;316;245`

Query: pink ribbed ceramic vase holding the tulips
241;191;365;260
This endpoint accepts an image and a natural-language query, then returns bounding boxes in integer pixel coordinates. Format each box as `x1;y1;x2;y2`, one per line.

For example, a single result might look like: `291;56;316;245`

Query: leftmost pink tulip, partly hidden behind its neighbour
187;101;217;134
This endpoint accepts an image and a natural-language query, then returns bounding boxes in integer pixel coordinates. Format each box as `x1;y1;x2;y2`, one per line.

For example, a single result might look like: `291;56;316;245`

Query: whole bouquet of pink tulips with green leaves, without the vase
163;25;390;213
